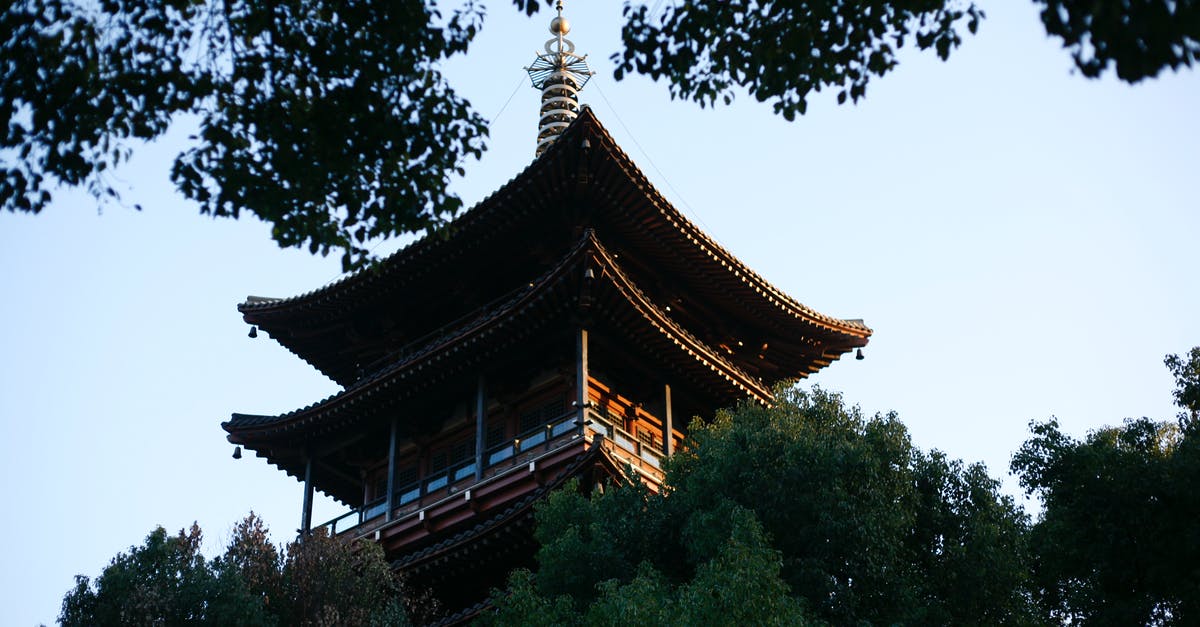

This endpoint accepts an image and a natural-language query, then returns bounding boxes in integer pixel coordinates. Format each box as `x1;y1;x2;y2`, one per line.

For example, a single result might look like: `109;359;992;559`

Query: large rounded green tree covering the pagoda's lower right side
482;381;1038;625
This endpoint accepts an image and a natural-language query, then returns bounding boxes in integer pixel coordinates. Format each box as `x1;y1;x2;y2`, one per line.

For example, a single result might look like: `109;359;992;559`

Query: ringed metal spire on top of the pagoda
526;0;595;156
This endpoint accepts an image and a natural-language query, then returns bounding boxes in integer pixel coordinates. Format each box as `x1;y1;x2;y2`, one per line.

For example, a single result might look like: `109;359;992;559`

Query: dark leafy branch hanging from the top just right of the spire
613;0;983;120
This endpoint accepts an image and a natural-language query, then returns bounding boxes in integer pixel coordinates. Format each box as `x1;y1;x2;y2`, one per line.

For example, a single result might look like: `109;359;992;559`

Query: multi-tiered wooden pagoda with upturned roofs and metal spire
222;4;871;622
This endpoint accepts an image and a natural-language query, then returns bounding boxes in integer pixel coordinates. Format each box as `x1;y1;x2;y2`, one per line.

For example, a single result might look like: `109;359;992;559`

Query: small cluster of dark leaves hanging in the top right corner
1034;0;1200;83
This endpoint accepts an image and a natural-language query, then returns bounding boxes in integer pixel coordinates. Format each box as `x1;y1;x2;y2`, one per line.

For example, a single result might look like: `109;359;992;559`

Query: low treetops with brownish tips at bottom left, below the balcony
59;513;439;626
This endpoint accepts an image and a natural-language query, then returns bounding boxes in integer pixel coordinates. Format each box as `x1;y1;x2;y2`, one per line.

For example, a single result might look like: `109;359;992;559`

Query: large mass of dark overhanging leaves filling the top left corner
0;0;486;268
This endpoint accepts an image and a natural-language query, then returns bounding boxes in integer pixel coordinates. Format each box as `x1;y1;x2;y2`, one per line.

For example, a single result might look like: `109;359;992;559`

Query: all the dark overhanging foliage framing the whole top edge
0;0;1200;269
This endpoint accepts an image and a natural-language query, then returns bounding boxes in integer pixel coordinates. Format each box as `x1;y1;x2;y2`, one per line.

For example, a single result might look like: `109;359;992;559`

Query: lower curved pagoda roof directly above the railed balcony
222;231;770;466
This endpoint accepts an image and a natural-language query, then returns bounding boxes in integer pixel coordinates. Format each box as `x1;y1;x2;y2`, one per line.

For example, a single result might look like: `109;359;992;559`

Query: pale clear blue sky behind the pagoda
0;0;1200;625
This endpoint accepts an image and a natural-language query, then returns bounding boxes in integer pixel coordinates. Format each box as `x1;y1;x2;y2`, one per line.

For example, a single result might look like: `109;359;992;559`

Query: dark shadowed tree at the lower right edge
1012;348;1200;625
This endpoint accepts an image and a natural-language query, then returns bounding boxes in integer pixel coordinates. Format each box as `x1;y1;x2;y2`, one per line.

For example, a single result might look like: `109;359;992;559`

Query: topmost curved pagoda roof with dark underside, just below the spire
234;108;871;386
